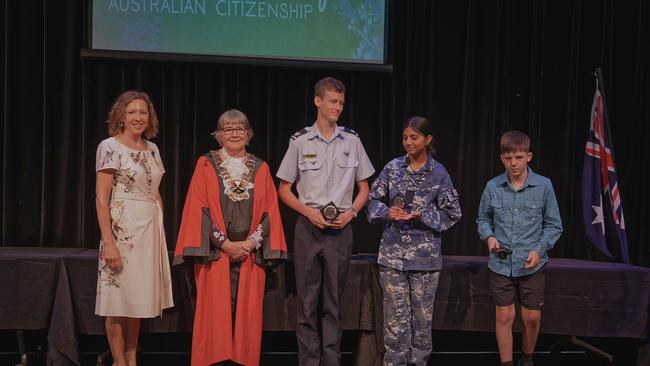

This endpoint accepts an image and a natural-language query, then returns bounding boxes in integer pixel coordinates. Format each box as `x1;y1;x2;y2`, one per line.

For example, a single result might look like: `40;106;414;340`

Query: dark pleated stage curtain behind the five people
0;0;650;266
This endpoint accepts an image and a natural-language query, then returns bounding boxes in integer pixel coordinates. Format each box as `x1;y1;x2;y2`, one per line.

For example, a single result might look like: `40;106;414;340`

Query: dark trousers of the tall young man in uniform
293;216;352;366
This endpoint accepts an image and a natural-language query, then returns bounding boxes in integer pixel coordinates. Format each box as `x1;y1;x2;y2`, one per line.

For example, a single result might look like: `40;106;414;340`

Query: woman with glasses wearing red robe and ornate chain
174;109;287;366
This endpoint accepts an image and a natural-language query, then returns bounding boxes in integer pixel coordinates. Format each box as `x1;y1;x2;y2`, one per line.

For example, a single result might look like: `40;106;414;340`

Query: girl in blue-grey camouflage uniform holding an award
366;117;461;366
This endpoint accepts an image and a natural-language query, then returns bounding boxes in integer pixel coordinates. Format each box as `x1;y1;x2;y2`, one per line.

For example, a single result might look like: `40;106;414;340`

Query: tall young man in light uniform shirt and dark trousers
276;77;375;366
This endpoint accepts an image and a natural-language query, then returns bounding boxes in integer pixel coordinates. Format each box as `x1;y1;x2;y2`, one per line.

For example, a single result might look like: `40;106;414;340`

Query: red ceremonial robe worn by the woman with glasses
174;155;287;366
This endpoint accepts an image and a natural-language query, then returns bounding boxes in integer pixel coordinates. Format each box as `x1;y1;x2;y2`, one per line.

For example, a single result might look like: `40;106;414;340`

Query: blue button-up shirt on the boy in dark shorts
476;168;562;277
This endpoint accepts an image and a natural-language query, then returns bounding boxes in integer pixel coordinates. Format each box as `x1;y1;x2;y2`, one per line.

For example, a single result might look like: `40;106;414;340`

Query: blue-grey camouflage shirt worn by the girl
366;155;461;271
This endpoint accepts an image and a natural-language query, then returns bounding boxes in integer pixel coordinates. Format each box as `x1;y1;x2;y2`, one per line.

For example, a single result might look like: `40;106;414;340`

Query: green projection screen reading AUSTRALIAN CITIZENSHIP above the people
91;0;386;64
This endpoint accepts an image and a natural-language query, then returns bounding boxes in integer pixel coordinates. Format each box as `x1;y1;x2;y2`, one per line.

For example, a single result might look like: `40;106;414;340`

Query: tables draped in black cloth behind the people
0;247;650;365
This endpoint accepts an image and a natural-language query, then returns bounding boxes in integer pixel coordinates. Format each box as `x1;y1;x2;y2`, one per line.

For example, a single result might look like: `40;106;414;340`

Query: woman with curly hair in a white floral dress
95;91;173;366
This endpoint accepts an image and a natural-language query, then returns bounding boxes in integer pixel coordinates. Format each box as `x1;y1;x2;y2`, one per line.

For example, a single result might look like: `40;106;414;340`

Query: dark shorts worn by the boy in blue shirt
490;268;545;310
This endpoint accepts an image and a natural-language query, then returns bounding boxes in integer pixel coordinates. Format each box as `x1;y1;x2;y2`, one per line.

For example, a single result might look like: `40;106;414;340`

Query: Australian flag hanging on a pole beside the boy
582;83;630;263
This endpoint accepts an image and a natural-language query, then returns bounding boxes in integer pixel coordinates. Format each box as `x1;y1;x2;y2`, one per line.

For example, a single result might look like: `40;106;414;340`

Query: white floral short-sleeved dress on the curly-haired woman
95;137;174;318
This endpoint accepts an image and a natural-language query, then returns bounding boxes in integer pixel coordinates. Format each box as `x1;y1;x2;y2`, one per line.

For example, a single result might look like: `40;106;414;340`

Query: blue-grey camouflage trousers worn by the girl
379;265;440;366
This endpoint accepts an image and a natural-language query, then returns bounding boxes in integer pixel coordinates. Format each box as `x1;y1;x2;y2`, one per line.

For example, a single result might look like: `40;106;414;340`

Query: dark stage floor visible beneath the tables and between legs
0;330;648;366
